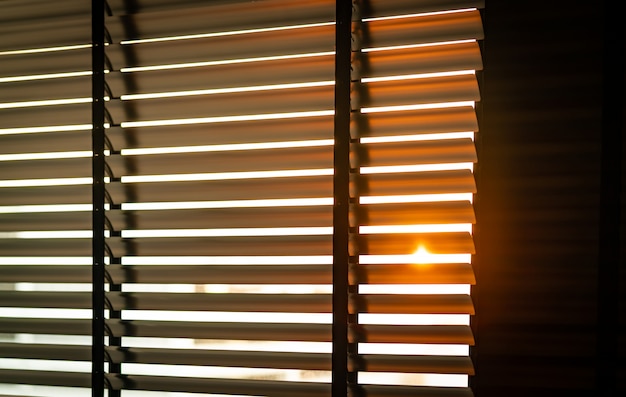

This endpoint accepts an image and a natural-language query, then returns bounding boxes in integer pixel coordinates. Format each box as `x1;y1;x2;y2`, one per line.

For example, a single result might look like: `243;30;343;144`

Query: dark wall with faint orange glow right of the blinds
471;0;626;397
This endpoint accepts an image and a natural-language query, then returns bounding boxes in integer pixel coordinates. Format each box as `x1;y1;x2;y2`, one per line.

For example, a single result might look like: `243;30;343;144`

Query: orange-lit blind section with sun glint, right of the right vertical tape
350;0;481;397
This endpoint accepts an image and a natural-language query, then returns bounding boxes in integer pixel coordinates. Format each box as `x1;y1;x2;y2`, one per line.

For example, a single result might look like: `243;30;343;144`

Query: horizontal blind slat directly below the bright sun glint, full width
0;260;475;284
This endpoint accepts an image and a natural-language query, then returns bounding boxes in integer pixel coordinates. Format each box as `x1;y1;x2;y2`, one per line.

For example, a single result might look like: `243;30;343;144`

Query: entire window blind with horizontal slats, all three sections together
0;0;482;397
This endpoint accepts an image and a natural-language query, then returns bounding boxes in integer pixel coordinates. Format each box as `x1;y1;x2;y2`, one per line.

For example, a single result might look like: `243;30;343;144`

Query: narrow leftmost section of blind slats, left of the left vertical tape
0;0;91;397
